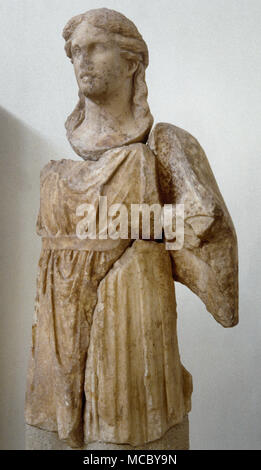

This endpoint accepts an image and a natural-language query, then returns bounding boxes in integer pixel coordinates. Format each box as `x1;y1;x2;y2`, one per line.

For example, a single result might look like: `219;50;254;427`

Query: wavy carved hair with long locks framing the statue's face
63;8;153;138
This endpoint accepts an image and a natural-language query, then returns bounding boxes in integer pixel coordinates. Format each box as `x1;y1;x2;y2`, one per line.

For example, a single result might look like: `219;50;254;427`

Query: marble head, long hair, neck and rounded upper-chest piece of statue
63;8;153;159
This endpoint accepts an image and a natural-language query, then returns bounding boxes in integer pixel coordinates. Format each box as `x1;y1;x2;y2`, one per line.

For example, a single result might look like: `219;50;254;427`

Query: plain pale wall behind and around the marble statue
0;0;261;449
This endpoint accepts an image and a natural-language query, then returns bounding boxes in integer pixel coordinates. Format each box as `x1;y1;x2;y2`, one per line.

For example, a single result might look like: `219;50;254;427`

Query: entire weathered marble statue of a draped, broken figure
25;8;238;449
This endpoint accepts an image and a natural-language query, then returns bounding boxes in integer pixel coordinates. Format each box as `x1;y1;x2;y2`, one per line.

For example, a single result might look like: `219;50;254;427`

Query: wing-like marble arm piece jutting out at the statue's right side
148;123;238;327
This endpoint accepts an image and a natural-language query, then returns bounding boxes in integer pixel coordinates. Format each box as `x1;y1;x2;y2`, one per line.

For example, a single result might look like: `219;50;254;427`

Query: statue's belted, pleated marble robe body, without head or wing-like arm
26;144;192;447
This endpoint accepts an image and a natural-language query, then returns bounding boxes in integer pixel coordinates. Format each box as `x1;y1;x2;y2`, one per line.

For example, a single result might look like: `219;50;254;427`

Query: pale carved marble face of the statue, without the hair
71;21;129;100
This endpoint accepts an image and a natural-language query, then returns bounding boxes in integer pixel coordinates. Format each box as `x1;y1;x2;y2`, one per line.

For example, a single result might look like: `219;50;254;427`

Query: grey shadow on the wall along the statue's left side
0;107;62;449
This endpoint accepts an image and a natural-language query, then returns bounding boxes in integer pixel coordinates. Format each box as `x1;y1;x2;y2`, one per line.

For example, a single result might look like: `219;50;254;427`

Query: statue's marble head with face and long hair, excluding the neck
63;8;153;158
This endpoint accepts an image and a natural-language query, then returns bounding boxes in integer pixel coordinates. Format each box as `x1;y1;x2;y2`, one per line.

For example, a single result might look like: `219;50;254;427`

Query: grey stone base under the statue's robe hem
25;416;189;450
